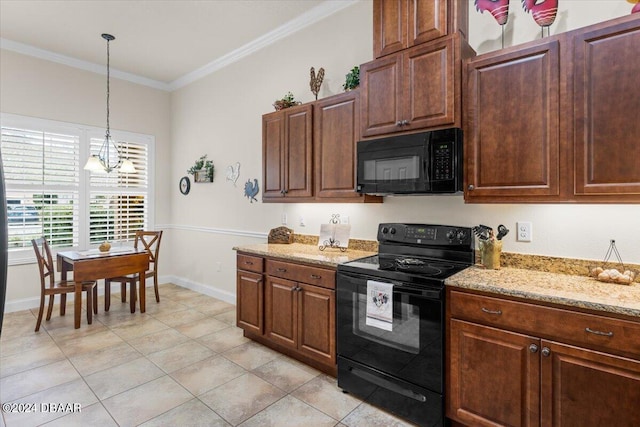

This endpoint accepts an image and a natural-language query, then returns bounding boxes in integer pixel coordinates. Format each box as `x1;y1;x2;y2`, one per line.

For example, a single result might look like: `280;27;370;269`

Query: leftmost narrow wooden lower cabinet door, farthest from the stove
236;270;264;334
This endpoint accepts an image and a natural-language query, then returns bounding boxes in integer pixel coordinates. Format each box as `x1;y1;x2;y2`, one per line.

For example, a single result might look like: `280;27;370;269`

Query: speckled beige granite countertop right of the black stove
445;266;640;320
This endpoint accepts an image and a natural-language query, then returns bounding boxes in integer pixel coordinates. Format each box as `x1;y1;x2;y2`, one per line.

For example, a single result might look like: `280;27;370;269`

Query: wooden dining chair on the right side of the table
104;231;162;313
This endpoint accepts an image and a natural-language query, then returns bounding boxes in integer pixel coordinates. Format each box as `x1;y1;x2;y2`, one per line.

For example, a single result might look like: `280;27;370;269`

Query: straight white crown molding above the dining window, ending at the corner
0;38;171;91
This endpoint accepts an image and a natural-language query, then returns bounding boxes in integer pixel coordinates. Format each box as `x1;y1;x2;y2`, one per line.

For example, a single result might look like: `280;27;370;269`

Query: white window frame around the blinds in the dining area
0;113;155;265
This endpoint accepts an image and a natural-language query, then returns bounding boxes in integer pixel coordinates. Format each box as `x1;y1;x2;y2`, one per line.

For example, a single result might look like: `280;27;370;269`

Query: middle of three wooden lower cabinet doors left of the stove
264;276;298;348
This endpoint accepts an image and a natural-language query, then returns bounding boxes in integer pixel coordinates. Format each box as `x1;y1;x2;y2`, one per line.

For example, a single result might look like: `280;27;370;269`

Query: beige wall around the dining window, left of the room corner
0;50;176;309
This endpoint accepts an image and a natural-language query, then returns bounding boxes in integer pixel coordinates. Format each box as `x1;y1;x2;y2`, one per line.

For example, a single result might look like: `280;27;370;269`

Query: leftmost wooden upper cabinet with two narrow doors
262;104;313;201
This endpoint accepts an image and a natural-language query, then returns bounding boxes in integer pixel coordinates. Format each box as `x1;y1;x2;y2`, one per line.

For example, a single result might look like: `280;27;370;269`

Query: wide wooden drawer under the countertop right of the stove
450;291;640;359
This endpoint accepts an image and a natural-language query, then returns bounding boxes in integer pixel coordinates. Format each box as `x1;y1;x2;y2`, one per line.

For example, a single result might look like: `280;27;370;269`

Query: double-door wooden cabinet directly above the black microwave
360;33;472;137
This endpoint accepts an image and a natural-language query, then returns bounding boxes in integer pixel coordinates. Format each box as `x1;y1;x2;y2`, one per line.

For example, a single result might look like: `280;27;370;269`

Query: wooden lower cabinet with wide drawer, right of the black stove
447;291;640;427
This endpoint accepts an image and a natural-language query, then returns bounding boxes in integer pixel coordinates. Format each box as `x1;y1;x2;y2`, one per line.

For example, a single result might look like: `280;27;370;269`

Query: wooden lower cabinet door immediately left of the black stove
298;283;336;365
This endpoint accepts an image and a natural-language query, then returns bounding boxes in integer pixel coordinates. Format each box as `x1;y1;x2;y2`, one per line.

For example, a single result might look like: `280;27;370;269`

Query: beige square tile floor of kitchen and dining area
0;284;416;427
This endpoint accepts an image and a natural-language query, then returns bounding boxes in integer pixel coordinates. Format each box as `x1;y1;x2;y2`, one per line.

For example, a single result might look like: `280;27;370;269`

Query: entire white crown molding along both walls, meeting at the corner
0;0;358;92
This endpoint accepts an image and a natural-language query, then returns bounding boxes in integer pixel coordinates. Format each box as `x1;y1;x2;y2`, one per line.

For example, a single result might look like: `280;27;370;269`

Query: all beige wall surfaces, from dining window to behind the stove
0;0;640;312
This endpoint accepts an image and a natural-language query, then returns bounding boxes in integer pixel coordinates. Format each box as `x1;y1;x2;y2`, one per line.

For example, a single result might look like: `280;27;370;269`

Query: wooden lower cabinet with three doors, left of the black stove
237;252;337;376
